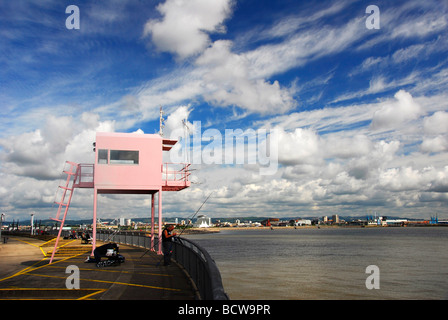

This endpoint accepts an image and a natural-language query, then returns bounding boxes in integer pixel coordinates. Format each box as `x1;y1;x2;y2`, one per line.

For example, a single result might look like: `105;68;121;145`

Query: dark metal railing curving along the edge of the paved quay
96;231;229;300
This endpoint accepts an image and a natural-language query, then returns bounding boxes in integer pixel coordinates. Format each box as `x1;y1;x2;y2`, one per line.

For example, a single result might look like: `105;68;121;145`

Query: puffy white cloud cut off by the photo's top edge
143;0;233;59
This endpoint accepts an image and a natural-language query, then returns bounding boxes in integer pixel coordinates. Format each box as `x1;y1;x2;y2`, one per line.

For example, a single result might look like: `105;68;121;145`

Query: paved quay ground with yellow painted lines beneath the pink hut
0;236;195;300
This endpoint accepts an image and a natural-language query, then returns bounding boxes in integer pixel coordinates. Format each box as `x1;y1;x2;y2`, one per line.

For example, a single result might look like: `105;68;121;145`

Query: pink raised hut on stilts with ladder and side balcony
50;132;190;263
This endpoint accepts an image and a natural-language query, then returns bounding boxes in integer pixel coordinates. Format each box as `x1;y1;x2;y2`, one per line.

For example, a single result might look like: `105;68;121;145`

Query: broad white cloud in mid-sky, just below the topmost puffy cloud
136;40;297;115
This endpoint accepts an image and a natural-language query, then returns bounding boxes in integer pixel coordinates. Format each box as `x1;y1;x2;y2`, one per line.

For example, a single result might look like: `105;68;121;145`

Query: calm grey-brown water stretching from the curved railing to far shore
185;227;448;300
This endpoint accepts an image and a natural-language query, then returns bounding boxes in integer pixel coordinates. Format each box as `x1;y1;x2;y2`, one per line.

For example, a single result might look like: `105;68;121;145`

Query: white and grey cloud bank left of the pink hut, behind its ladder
0;112;114;216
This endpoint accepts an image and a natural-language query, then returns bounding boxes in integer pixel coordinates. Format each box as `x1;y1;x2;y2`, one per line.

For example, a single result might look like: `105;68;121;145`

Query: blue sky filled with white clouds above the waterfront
0;0;448;219
